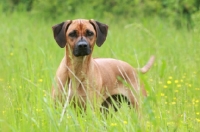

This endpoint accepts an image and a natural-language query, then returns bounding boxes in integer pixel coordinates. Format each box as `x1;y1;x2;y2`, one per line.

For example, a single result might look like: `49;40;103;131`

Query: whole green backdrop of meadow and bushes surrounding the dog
0;0;200;132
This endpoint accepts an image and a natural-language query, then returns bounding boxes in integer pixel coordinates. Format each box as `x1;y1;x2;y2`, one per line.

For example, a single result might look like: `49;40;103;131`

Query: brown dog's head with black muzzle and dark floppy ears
52;19;108;57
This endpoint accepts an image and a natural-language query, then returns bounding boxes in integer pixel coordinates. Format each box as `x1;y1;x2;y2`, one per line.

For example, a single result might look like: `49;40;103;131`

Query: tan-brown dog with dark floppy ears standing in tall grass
52;19;154;108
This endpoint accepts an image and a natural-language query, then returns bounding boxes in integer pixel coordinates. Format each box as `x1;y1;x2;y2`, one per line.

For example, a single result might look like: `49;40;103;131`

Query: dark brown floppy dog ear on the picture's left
52;20;72;48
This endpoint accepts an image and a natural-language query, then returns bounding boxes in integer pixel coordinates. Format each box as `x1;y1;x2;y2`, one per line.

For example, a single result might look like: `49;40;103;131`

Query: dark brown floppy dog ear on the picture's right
90;19;108;47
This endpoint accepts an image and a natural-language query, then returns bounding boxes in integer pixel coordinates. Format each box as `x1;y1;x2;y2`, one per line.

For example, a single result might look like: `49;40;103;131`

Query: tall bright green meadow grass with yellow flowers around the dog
0;13;200;132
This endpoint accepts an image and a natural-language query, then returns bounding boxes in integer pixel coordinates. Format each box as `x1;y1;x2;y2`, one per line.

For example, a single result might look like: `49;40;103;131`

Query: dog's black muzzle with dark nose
73;40;91;57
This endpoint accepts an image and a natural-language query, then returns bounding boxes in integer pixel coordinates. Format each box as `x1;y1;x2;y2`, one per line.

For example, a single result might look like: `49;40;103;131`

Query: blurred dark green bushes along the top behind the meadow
0;0;200;28
